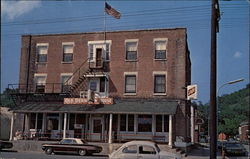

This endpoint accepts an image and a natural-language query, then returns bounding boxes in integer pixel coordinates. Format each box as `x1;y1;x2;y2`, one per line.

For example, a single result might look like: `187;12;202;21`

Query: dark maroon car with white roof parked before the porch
42;138;102;156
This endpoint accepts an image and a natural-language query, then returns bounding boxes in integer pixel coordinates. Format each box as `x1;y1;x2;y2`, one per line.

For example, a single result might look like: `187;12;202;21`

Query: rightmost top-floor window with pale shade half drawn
155;40;166;59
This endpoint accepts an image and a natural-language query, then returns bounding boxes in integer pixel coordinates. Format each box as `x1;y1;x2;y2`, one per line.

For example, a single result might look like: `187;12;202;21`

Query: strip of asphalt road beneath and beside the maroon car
0;150;108;159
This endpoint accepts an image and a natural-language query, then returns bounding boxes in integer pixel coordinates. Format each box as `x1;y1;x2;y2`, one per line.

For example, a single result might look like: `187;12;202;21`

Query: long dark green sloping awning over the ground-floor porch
12;99;179;114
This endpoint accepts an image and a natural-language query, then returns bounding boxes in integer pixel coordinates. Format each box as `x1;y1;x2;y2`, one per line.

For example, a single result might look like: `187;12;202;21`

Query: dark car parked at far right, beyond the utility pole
223;142;247;156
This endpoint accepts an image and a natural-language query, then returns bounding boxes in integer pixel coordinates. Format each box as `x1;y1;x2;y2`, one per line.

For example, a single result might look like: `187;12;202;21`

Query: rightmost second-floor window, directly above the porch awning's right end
154;75;166;93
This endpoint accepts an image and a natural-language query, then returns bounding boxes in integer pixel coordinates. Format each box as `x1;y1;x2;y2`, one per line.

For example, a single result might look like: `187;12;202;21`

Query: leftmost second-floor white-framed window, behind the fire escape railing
34;74;47;93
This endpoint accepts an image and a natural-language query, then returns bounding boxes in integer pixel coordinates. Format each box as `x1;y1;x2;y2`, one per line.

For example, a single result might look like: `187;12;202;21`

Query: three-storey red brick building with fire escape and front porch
9;28;191;146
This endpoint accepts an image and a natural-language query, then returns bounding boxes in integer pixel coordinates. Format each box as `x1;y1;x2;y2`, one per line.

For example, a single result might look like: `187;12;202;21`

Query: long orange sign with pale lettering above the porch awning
64;98;113;104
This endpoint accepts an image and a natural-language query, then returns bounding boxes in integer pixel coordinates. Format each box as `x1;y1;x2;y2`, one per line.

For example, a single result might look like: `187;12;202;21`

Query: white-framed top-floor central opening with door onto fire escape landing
88;40;111;62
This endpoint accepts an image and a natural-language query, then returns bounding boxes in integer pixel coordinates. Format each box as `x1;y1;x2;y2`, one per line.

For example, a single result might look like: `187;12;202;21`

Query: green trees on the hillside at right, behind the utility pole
193;84;250;136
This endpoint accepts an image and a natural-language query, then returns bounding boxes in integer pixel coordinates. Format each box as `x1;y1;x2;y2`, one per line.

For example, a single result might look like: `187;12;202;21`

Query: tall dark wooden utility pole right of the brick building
209;0;219;159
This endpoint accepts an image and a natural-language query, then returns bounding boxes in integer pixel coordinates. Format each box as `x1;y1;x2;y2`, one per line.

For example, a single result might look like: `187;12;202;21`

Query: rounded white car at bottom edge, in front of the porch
109;141;181;159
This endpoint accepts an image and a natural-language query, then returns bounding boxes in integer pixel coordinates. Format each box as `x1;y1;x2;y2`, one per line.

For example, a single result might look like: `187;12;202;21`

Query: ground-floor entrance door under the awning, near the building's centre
91;118;103;141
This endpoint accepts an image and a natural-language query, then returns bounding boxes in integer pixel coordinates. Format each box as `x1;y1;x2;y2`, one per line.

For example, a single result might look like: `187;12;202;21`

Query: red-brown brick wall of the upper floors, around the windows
20;29;190;99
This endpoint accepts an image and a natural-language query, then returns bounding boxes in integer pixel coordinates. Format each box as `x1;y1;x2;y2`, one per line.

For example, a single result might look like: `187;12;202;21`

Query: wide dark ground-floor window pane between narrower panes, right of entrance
138;115;152;132
